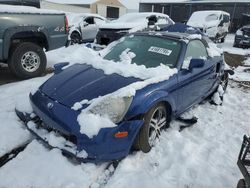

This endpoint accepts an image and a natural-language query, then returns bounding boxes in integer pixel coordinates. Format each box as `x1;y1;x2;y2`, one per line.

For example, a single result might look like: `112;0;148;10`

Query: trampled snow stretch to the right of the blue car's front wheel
107;83;250;188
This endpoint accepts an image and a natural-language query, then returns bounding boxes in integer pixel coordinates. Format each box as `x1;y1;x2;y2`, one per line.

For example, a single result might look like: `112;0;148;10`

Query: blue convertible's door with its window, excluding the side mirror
178;39;216;111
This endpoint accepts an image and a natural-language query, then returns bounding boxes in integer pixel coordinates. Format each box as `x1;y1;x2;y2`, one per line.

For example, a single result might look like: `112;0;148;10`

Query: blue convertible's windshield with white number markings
104;35;181;68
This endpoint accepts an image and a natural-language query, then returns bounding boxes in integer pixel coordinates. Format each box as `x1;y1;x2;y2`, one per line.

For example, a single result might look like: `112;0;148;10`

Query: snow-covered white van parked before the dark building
187;10;230;42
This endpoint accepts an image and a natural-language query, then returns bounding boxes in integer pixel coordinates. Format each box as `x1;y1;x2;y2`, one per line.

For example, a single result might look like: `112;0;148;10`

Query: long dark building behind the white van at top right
139;0;250;31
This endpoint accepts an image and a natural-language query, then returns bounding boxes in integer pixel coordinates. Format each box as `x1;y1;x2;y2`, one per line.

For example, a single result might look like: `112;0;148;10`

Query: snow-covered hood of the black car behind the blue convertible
100;21;147;29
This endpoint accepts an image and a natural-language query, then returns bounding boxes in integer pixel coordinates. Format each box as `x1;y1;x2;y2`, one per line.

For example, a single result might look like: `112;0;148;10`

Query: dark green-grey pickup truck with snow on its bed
0;5;68;79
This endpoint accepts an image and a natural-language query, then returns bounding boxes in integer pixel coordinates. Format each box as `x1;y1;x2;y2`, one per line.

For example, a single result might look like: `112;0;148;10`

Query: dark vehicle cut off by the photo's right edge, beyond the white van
233;25;250;48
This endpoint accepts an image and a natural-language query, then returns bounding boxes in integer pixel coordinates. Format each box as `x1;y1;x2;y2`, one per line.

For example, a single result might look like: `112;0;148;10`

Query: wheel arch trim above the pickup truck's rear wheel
3;26;50;59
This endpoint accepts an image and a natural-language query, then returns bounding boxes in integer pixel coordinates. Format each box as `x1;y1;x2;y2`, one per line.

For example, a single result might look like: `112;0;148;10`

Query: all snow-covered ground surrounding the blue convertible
0;35;250;188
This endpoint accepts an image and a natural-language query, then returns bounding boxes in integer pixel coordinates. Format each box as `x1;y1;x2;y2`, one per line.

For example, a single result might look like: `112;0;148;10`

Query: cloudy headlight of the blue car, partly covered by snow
89;97;133;123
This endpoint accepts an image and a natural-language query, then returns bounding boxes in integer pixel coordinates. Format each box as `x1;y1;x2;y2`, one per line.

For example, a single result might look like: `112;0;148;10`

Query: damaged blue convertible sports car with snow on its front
16;32;228;162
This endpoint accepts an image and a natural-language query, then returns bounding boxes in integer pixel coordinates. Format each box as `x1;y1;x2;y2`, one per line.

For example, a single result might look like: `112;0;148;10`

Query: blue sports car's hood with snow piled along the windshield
40;44;177;107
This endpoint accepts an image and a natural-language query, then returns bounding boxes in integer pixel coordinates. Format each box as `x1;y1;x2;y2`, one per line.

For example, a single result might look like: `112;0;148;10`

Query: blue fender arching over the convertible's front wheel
127;90;176;118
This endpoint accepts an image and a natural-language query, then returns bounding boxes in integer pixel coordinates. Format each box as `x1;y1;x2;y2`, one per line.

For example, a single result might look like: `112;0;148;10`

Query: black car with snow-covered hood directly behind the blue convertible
96;12;174;45
